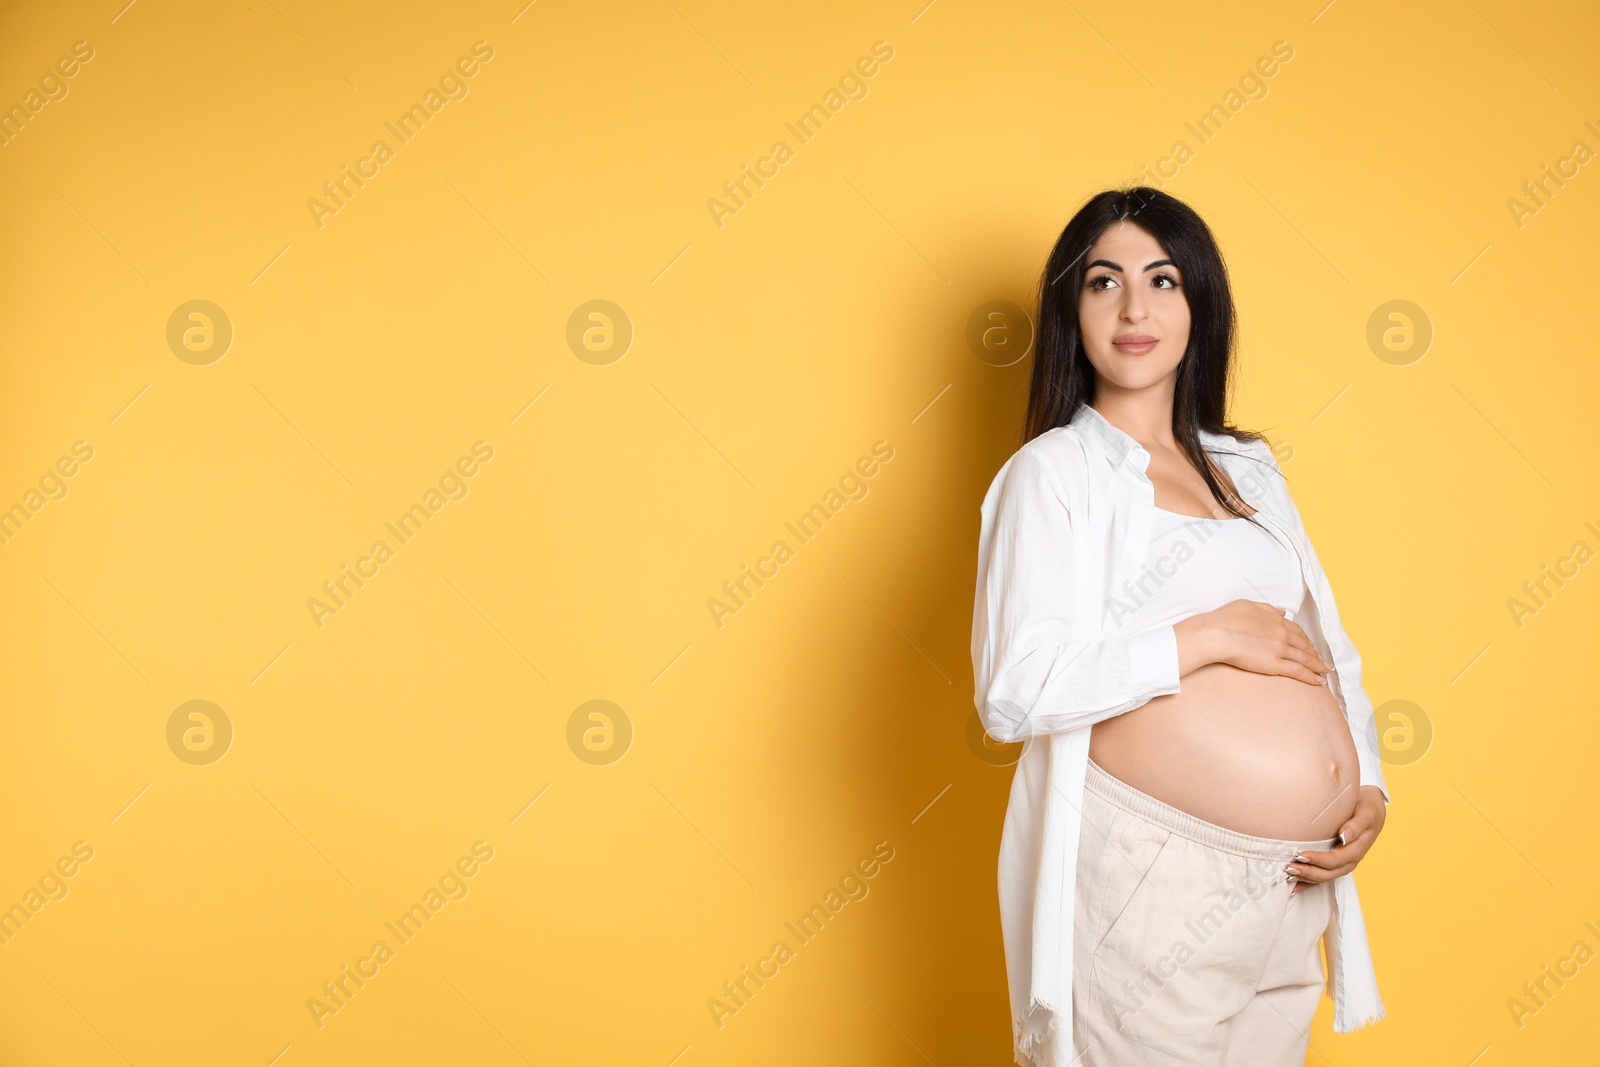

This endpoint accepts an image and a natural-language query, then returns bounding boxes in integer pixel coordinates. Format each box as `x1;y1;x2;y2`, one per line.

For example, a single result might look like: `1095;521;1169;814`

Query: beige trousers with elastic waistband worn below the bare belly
1072;760;1338;1067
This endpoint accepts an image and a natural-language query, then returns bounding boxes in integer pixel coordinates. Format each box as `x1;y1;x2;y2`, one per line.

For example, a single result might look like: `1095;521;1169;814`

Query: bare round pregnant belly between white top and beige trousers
1090;664;1360;841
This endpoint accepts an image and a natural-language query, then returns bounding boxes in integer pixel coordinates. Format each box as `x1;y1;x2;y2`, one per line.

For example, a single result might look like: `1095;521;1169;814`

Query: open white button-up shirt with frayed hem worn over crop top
973;405;1389;1067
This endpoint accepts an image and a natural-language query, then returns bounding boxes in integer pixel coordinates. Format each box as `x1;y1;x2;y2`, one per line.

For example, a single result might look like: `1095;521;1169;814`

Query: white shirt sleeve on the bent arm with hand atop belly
973;446;1179;744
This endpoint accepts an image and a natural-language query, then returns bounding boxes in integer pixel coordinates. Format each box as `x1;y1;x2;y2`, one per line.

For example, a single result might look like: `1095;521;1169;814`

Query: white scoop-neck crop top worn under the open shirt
1112;507;1306;635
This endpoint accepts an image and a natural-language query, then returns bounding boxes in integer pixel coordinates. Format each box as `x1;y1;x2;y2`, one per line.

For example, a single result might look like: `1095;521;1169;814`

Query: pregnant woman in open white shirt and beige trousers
973;187;1389;1067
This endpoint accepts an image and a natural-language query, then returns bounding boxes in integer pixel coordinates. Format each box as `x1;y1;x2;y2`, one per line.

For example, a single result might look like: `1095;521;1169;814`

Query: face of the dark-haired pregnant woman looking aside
1078;219;1189;390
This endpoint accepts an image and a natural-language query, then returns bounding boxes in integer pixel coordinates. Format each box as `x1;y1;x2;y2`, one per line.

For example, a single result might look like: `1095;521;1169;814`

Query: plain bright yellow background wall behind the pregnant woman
0;0;1600;1067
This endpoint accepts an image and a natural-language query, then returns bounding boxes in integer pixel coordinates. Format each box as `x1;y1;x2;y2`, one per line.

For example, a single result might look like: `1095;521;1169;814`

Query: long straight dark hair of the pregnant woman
1022;186;1266;518
